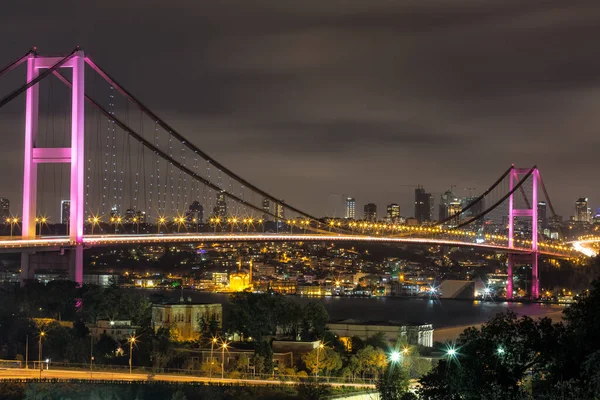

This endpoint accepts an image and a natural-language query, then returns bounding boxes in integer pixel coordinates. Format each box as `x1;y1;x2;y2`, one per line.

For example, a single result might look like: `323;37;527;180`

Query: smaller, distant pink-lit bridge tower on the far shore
506;166;540;299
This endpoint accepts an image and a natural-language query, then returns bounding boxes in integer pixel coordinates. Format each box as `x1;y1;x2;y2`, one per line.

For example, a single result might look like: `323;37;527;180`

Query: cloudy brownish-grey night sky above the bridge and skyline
0;0;600;217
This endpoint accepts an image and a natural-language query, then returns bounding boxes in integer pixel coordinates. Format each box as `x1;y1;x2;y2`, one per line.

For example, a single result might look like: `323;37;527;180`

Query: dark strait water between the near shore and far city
148;290;564;329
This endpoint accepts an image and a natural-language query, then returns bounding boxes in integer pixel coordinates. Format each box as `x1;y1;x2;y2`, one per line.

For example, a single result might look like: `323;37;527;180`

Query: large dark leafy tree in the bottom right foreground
414;312;564;399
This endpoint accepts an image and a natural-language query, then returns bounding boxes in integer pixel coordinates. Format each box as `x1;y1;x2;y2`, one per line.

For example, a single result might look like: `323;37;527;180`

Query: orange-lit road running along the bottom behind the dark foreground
0;368;375;389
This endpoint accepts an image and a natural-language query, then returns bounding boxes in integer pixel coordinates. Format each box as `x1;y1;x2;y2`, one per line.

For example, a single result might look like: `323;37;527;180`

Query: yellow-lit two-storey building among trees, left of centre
152;301;223;341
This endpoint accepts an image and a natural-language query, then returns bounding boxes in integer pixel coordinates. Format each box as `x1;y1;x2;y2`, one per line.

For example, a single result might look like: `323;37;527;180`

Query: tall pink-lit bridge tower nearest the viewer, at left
21;51;85;284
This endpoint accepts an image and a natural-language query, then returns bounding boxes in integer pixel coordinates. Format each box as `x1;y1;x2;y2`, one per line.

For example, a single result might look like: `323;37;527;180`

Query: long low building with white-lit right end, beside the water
327;319;433;347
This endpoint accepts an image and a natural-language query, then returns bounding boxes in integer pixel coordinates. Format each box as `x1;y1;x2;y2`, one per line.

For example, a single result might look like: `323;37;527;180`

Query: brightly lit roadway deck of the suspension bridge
0;233;573;257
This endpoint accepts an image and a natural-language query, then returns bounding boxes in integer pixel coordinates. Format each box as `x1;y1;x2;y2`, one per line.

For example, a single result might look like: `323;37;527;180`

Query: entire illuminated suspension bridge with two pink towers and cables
0;48;584;298
